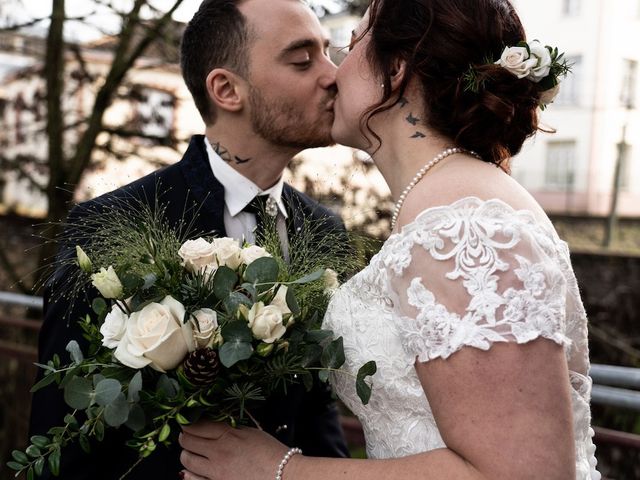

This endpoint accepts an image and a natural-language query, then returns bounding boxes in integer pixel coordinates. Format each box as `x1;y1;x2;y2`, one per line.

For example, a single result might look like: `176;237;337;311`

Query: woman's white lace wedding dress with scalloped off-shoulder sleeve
323;197;600;480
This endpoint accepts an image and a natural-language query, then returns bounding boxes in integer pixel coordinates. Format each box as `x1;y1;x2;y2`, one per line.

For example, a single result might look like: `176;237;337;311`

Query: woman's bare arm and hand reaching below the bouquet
181;339;575;480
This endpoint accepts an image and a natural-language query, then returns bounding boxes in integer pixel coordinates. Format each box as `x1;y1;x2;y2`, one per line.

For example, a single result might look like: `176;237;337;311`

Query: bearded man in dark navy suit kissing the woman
31;0;348;480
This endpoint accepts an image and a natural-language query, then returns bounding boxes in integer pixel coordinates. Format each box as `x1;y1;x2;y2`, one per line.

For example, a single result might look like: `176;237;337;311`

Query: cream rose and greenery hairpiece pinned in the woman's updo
462;40;571;110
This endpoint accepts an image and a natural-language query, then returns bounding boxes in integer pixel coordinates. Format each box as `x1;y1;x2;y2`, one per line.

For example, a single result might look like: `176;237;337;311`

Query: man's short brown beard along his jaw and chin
249;85;334;149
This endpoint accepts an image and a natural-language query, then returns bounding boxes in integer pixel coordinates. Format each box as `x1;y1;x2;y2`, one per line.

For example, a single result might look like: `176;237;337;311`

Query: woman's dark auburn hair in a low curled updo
363;0;540;171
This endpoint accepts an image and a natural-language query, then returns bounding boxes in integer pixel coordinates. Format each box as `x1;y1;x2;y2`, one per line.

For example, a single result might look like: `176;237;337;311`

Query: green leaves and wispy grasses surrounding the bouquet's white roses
9;190;375;477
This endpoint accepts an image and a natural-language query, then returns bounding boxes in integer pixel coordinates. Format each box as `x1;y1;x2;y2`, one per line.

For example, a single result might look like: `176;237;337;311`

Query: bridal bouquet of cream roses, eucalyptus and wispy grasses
8;199;376;479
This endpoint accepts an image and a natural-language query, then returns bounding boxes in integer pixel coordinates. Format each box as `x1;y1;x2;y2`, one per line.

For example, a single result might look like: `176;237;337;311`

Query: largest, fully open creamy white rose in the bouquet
114;296;194;372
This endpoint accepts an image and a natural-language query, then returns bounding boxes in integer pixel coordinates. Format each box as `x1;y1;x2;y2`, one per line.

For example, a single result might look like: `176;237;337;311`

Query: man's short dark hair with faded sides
180;0;251;125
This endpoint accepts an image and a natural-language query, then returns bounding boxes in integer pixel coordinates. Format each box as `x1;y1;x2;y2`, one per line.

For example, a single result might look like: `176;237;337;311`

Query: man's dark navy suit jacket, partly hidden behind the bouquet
30;136;348;480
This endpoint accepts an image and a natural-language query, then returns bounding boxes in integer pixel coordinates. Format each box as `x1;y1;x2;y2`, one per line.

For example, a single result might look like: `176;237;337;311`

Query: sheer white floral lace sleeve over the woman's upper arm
385;199;570;361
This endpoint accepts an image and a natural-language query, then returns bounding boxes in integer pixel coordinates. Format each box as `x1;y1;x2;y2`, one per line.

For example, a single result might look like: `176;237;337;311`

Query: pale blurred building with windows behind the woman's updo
514;0;640;217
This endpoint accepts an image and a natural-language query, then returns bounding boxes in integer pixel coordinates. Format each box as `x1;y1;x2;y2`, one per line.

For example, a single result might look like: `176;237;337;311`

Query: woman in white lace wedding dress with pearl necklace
180;0;600;480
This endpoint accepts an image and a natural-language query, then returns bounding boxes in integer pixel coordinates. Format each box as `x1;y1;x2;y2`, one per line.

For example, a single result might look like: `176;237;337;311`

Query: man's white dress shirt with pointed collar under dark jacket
204;137;289;258
